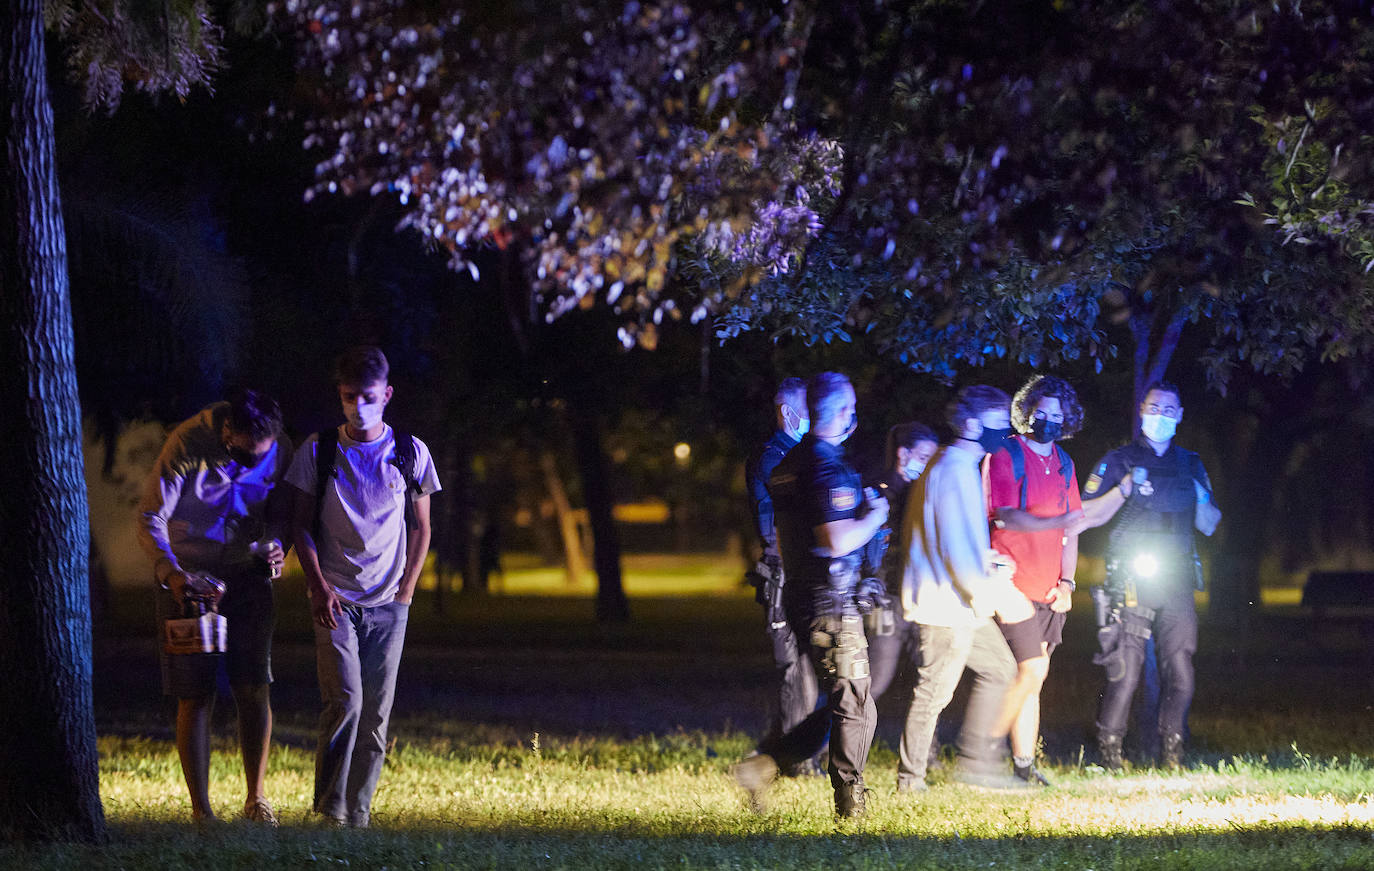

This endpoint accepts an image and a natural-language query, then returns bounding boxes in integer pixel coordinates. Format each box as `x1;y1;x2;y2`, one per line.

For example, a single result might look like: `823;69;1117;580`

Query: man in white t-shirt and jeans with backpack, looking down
286;346;440;827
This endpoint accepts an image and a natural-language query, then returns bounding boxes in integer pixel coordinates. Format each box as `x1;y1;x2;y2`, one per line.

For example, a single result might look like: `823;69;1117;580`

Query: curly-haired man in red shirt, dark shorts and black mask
987;375;1084;786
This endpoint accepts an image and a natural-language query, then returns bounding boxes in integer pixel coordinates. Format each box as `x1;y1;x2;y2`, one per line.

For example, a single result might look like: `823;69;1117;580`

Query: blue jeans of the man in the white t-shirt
315;602;411;827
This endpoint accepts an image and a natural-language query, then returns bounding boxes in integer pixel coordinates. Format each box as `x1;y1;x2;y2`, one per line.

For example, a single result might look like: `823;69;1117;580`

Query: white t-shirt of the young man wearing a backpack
286;426;440;607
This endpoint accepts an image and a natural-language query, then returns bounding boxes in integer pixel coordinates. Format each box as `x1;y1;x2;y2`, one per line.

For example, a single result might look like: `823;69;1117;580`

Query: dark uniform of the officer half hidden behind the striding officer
745;430;818;738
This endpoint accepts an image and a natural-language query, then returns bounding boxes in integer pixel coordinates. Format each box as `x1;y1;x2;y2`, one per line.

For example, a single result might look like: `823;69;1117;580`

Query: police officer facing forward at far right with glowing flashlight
1083;382;1221;771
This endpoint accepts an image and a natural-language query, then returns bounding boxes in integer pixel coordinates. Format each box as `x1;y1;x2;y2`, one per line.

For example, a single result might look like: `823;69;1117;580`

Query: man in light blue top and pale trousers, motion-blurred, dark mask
901;385;1032;790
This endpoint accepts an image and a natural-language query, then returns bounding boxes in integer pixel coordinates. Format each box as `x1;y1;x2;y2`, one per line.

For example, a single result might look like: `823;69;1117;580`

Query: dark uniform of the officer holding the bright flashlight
1083;434;1212;742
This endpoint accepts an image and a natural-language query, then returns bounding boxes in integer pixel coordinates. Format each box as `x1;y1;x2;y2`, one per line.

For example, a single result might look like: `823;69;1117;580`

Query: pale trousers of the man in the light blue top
897;618;1017;784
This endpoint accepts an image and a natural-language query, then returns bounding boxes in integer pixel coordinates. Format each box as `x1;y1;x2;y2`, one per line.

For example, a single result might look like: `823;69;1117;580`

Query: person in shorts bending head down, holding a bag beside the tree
139;390;291;826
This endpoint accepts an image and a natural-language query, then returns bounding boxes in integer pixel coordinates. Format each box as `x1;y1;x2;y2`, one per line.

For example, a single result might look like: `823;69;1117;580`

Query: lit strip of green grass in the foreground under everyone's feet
8;727;1374;868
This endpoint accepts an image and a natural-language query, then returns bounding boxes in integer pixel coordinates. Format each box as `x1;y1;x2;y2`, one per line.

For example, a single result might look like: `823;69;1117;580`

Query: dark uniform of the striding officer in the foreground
760;436;877;793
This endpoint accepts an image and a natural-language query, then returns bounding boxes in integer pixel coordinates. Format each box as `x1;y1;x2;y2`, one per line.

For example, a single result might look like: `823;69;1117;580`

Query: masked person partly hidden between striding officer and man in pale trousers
864;422;940;793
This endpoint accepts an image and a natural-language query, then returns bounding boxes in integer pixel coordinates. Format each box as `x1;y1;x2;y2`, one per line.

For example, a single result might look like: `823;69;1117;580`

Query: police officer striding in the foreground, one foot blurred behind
732;372;888;817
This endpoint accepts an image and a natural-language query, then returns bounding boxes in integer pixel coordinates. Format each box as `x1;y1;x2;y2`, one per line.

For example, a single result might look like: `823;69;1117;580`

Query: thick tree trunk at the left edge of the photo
0;0;106;842
